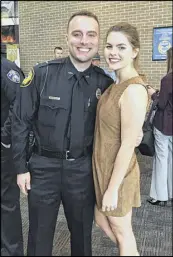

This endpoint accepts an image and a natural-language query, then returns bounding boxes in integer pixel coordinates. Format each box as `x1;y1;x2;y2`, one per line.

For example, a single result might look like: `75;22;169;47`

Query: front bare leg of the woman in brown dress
107;210;139;256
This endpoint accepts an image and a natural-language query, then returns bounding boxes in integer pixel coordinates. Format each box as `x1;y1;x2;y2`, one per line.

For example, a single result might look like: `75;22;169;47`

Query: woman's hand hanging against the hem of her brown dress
102;188;118;211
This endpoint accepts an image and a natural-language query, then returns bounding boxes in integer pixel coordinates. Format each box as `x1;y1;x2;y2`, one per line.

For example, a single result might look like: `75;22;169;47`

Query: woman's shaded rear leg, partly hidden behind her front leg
94;206;117;244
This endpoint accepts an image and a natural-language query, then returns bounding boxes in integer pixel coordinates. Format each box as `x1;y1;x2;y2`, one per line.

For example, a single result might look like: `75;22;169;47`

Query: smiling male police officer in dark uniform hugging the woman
13;12;113;256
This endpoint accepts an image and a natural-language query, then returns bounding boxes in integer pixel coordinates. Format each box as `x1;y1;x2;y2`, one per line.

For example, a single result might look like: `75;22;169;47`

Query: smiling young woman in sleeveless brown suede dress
93;23;148;256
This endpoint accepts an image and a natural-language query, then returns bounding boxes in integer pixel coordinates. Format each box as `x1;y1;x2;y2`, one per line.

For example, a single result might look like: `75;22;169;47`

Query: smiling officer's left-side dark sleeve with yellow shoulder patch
12;67;39;174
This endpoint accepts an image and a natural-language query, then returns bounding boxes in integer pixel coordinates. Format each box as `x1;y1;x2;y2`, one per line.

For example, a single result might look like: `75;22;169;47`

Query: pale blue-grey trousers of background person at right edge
150;128;173;201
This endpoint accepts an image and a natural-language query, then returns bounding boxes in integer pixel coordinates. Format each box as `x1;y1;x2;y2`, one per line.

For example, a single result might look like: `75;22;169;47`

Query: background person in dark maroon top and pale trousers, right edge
148;47;173;206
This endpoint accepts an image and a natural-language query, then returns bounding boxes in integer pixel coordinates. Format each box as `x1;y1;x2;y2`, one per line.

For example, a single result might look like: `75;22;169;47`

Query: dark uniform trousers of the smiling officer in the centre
27;154;95;256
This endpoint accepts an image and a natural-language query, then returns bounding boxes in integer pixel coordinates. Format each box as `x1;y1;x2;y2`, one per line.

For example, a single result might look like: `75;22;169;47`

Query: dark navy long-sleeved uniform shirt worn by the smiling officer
12;57;113;173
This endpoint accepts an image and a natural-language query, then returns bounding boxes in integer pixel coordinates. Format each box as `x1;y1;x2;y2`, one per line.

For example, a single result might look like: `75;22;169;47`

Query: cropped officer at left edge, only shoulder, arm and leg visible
1;56;24;256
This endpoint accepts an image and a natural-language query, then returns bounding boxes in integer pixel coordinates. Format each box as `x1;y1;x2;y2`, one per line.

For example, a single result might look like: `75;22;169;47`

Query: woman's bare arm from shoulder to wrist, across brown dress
108;84;148;190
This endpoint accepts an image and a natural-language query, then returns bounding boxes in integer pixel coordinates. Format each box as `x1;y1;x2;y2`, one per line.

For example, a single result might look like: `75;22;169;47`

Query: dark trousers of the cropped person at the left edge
1;149;24;256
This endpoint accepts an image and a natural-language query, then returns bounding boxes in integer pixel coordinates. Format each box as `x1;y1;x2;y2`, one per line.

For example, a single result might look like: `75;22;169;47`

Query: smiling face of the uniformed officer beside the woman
67;16;99;63
